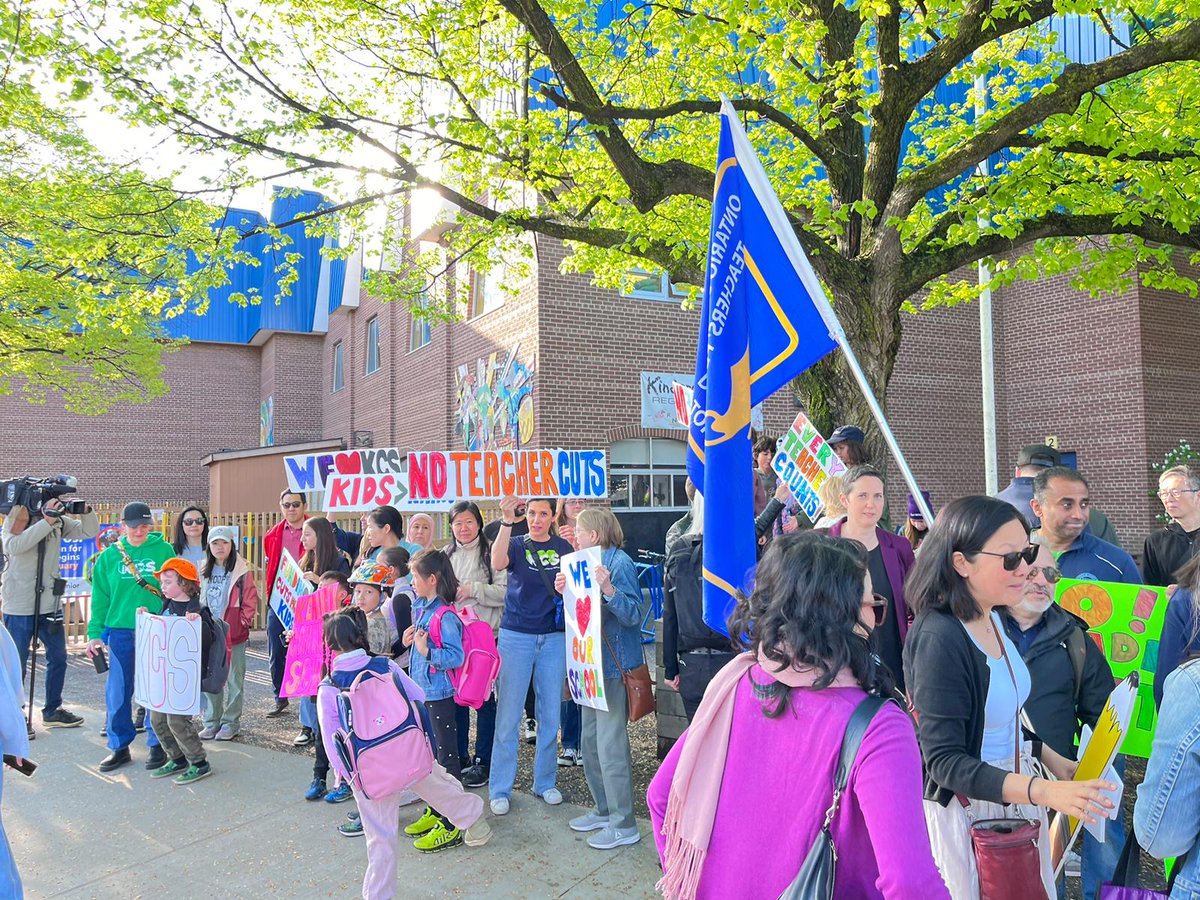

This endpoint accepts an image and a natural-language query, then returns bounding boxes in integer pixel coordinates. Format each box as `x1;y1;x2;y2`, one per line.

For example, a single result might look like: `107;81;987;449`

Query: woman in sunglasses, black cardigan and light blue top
904;497;1114;900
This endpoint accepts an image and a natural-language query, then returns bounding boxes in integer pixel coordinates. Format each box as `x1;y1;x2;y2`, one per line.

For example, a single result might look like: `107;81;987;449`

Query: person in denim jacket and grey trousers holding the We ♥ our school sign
554;506;646;850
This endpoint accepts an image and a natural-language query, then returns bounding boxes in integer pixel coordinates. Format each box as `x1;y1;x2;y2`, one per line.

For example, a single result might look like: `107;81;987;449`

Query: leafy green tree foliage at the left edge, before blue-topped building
0;8;246;413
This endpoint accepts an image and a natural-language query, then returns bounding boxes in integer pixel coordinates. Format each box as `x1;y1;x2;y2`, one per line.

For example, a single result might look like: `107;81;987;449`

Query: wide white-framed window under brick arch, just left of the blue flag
608;438;688;511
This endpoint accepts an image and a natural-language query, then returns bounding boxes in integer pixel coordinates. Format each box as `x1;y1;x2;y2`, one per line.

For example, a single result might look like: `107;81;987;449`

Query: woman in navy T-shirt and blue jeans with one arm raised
488;497;572;816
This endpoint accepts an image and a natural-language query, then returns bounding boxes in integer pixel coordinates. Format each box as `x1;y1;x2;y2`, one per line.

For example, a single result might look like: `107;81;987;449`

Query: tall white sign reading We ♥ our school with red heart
558;547;608;712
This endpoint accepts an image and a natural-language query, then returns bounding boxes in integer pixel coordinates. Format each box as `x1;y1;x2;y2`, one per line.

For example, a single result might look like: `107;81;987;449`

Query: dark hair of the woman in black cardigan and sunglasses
905;497;1030;622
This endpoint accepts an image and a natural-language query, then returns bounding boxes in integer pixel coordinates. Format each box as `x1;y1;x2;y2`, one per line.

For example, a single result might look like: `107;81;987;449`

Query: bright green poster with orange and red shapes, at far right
1055;578;1166;758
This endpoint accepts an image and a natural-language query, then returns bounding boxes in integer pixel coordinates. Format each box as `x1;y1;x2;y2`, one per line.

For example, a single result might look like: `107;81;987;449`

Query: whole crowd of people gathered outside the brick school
7;434;1200;900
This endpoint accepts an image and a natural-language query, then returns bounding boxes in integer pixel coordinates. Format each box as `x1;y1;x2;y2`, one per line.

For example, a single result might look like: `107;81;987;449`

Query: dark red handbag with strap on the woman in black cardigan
959;631;1046;900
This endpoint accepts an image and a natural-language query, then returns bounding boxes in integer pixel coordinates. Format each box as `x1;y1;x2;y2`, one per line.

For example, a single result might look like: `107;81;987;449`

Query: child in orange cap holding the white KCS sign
138;557;214;785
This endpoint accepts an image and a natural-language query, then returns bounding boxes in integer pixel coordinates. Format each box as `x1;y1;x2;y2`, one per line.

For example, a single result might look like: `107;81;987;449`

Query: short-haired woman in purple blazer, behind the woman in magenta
829;466;916;691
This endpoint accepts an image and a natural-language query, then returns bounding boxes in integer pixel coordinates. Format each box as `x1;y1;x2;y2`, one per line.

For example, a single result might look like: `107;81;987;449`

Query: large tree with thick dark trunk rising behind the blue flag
58;0;1200;436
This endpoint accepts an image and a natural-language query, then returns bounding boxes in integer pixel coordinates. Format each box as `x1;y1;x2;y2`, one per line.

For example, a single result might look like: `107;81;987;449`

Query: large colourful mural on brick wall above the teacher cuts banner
455;344;535;450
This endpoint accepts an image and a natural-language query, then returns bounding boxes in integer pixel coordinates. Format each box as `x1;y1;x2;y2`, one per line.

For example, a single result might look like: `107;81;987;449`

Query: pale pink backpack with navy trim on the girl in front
329;656;433;800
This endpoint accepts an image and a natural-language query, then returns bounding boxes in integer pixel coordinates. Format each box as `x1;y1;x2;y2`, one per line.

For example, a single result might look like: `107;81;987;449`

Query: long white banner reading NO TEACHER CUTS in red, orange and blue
407;450;608;509
